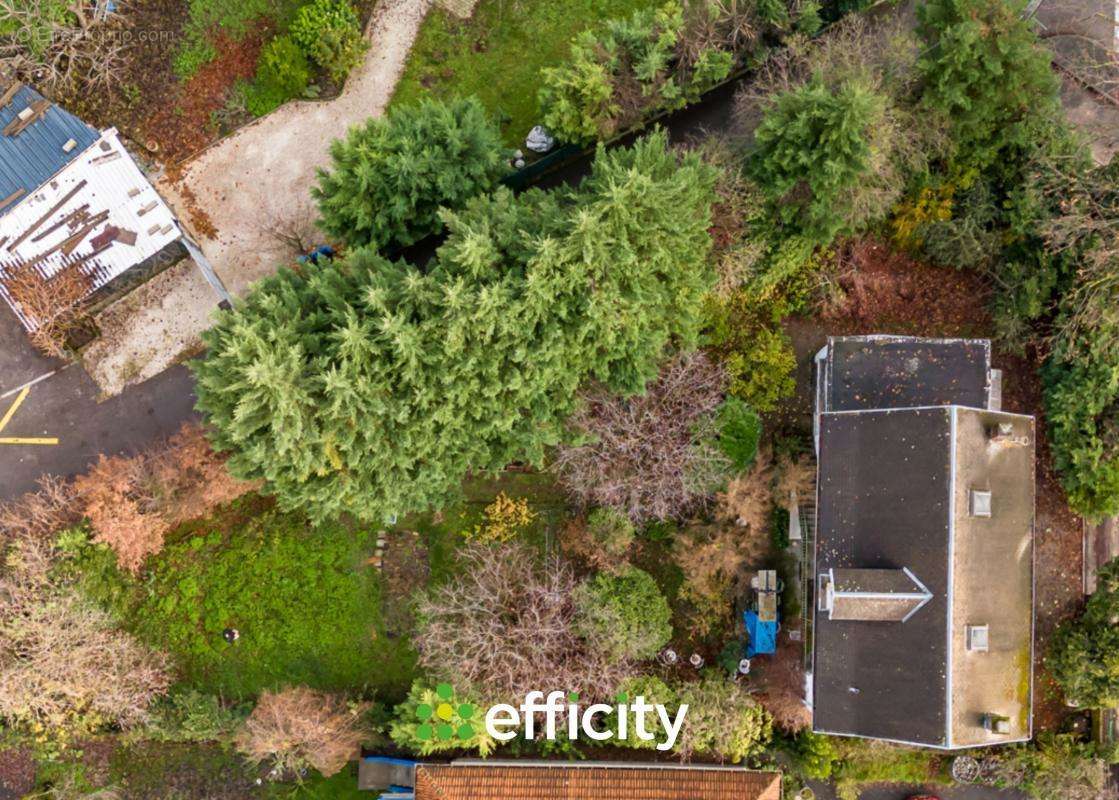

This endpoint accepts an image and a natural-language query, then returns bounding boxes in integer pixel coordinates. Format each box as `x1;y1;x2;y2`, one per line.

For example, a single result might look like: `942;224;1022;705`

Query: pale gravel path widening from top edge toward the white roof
160;0;431;295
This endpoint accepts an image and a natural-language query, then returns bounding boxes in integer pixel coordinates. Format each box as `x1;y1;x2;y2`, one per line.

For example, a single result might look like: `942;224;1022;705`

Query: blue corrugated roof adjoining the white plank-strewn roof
0;86;101;216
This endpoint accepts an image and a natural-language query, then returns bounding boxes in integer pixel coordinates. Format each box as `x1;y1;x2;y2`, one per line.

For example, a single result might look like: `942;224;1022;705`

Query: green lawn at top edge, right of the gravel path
393;0;657;145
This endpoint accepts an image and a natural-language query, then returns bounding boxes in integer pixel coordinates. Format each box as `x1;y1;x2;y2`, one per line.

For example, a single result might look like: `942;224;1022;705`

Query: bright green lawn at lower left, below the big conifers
69;498;415;699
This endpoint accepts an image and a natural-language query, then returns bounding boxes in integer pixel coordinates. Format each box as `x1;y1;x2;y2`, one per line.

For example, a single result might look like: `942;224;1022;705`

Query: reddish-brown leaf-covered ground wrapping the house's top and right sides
778;239;1083;731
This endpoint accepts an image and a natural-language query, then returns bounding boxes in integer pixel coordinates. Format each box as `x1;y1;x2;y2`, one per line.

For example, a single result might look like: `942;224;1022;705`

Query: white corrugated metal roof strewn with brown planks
0;129;181;330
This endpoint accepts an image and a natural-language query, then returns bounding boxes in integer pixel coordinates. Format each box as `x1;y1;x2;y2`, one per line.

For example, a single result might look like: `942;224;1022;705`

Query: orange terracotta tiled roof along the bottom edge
415;763;781;800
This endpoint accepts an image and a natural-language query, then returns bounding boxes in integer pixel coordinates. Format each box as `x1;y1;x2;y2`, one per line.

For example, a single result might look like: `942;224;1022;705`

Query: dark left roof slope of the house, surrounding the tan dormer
812;408;951;745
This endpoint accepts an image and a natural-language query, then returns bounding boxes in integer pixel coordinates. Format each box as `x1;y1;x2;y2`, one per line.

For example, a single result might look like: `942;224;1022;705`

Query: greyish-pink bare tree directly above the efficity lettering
415;544;624;698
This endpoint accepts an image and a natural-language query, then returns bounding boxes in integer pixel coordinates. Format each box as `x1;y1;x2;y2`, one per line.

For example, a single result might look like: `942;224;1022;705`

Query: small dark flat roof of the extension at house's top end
824;337;990;411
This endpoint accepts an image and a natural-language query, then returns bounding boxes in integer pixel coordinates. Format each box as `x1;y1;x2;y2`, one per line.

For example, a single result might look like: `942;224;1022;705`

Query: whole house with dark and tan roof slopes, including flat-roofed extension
810;336;1034;749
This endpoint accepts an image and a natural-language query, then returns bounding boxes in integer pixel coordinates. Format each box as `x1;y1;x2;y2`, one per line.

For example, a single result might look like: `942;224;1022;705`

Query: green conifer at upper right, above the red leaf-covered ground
751;75;886;245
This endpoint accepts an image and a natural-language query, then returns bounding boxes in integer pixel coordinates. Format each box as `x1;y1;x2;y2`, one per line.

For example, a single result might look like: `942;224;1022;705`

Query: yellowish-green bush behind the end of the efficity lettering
676;670;773;764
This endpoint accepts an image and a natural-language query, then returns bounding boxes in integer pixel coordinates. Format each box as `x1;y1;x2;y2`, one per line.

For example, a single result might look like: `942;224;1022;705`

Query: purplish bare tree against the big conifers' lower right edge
553;352;730;523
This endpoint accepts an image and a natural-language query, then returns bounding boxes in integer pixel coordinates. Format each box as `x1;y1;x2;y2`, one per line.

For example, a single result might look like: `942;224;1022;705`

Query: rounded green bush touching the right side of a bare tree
575;566;673;663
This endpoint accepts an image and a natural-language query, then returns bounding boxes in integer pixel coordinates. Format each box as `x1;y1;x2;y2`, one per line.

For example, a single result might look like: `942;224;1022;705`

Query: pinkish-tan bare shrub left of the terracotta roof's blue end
235;686;366;778
